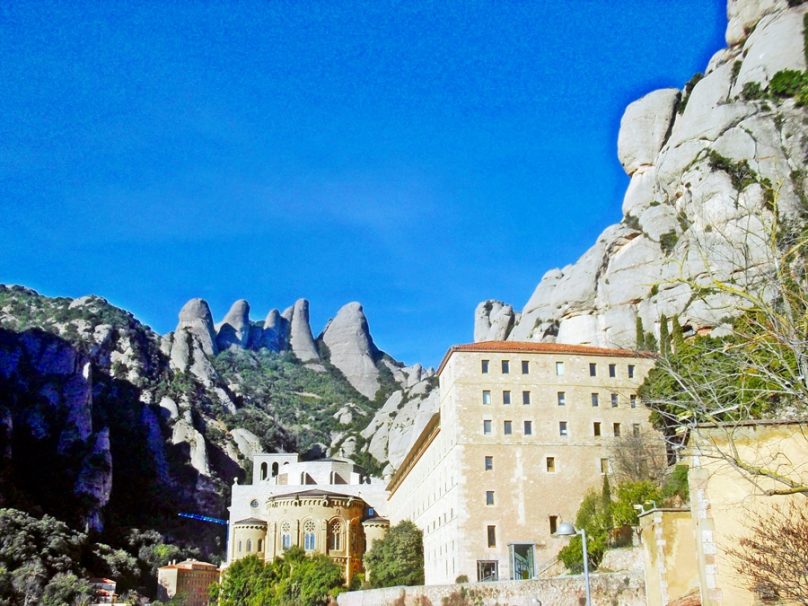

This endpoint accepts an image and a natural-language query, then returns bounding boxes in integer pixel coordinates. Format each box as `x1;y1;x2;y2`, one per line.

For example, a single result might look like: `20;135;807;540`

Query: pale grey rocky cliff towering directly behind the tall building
474;0;808;347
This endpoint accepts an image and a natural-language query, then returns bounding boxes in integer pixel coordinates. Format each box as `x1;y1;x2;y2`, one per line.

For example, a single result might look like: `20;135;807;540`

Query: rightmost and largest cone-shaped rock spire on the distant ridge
320;302;381;400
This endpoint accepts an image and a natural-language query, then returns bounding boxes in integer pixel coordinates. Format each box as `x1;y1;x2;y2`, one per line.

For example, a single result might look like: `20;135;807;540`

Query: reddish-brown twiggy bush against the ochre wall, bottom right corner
728;501;808;606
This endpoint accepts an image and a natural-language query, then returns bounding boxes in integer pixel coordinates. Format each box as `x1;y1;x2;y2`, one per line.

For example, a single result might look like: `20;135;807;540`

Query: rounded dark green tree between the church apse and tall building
365;520;424;587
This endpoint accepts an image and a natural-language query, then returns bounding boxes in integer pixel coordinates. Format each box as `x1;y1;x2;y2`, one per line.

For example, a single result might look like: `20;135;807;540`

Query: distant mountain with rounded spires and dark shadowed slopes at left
0;286;436;533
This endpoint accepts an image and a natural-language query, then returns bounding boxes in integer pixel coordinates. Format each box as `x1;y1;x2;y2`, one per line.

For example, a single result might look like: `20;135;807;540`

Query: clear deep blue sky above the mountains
0;0;726;365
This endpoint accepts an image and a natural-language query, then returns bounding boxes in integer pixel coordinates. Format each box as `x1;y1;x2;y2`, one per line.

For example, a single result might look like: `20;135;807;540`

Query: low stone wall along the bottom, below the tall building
337;573;645;606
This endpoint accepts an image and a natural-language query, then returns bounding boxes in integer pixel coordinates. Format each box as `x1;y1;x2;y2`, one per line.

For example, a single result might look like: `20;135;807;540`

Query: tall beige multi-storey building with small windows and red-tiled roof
388;341;664;585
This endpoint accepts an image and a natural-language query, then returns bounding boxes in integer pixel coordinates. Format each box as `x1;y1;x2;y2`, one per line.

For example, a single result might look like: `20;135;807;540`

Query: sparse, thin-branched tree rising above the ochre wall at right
640;201;808;496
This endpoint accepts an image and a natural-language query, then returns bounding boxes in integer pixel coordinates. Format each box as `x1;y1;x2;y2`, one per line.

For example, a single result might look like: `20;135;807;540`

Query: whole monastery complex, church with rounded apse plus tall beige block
228;341;664;585
